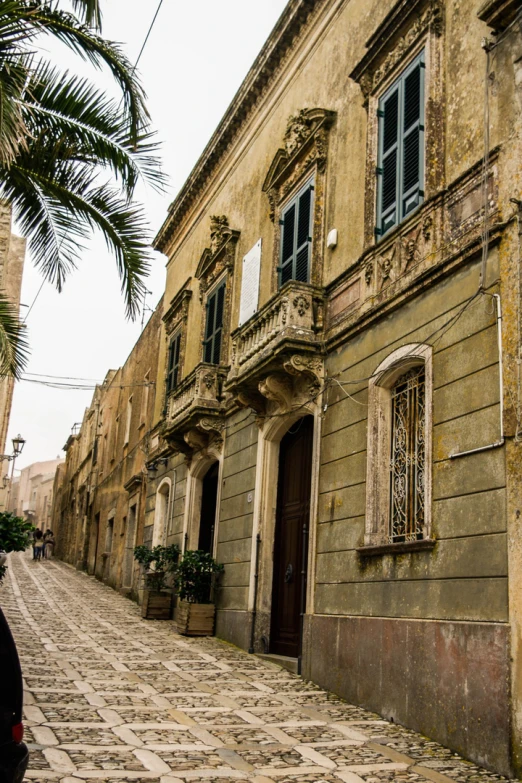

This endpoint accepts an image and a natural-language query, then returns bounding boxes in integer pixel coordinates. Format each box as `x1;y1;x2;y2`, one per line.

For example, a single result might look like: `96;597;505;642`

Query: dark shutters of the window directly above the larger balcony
279;182;314;286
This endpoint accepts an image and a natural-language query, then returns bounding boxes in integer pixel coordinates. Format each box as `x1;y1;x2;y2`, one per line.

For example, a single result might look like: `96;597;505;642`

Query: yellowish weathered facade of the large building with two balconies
51;0;522;774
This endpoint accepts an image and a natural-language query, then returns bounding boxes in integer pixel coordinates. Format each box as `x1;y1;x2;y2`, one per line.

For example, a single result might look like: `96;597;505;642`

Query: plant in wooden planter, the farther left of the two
134;544;179;620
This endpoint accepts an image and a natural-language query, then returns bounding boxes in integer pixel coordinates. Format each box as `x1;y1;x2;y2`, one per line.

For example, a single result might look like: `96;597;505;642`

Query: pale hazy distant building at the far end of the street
8;458;64;530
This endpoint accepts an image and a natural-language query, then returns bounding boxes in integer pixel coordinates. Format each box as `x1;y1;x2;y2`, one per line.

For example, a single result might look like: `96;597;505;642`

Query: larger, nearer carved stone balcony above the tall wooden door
225;280;324;413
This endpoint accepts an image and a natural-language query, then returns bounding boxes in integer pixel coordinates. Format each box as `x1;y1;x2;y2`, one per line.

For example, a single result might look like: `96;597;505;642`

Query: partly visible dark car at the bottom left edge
0;609;29;783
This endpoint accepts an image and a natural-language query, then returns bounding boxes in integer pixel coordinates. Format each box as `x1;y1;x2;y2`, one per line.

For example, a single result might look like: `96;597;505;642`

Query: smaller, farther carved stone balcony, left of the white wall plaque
161;362;227;452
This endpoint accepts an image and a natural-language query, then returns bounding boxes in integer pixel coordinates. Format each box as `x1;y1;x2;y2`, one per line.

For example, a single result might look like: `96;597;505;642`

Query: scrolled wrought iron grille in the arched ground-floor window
388;365;426;543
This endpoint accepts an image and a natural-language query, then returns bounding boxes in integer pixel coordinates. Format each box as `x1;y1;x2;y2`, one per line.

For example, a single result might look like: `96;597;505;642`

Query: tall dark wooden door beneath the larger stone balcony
270;416;314;658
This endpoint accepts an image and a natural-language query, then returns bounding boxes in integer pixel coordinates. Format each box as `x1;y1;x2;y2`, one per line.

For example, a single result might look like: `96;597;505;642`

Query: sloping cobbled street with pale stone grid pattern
0;555;504;783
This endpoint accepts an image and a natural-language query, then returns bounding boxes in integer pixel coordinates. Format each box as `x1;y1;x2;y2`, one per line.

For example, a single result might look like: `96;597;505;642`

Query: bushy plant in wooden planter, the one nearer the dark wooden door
174;549;224;636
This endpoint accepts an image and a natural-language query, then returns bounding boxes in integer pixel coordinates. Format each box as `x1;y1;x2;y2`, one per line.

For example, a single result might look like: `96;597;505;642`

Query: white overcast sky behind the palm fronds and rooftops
6;0;286;468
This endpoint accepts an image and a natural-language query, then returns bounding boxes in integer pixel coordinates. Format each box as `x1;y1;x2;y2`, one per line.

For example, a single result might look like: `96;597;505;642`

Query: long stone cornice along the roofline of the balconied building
154;0;328;252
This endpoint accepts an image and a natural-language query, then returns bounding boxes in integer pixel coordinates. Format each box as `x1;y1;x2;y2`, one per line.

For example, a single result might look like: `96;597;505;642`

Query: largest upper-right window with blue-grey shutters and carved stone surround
350;0;445;247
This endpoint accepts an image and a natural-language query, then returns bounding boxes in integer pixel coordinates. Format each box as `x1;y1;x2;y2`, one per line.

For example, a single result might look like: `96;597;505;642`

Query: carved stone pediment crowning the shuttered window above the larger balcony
263;104;335;221
